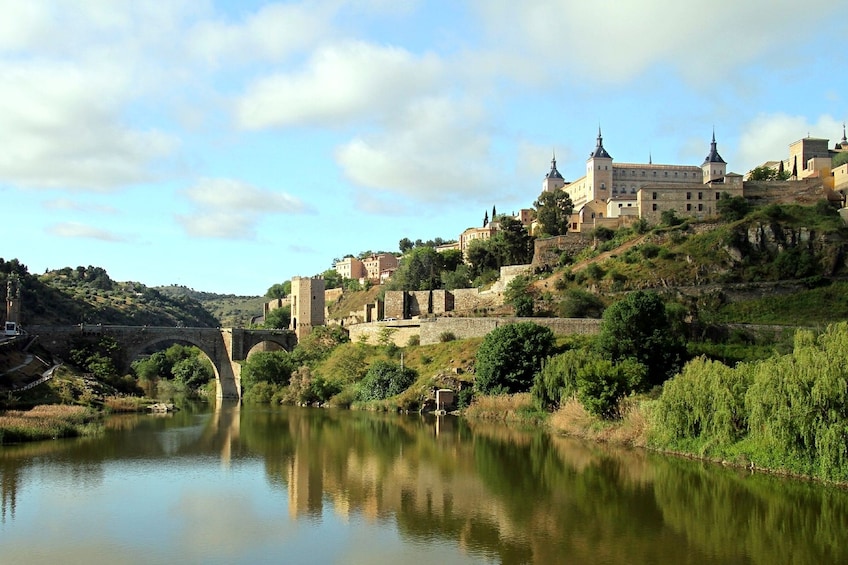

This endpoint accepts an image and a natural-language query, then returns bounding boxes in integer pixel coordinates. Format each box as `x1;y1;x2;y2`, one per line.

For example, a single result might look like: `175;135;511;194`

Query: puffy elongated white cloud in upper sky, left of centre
236;42;444;129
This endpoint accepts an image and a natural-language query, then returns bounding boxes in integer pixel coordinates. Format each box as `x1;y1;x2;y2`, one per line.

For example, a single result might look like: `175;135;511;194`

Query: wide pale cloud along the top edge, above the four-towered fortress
473;0;832;84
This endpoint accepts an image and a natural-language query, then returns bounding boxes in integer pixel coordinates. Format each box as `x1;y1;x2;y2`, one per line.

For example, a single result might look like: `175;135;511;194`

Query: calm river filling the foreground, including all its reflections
0;405;848;565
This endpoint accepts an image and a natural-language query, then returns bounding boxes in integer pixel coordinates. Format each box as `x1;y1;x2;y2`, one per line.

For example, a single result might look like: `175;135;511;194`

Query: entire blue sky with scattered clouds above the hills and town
0;0;848;296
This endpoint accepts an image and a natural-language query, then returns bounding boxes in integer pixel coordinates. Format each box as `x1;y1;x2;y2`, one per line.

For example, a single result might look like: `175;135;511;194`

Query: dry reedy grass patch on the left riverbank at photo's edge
0;405;98;444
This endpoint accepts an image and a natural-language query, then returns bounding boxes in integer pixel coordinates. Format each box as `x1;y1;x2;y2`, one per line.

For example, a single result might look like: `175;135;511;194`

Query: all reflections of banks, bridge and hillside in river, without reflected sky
0;404;848;565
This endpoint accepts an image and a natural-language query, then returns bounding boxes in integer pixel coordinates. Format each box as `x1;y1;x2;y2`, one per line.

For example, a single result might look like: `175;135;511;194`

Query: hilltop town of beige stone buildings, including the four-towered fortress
264;125;848;335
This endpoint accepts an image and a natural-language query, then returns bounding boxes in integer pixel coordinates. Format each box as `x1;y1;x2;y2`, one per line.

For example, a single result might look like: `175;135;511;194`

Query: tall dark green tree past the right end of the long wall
597;290;686;387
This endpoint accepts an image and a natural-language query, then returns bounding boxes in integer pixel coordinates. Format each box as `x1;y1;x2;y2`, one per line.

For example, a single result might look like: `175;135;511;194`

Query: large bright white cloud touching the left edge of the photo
0;63;177;191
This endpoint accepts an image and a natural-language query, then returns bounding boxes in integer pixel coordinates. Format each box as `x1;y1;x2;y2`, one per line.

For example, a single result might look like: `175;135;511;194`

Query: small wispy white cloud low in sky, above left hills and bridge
176;178;311;239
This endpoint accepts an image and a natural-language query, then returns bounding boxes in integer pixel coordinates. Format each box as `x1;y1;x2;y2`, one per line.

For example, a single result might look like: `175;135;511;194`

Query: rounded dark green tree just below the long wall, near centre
474;322;554;394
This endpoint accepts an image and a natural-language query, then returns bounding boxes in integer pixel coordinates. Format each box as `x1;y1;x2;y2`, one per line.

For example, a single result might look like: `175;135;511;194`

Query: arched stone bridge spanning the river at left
27;324;297;399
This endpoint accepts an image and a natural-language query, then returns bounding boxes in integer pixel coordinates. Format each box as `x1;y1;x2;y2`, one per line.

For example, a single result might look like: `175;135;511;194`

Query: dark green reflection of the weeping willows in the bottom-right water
655;459;848;564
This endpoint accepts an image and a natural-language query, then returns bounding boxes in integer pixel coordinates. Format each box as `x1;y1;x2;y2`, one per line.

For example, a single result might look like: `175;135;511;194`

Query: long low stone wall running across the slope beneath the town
348;317;601;347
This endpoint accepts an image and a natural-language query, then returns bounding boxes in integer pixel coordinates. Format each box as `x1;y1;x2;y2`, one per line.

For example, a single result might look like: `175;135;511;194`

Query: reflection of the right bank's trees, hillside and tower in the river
217;409;848;565
